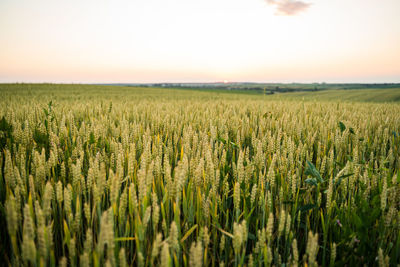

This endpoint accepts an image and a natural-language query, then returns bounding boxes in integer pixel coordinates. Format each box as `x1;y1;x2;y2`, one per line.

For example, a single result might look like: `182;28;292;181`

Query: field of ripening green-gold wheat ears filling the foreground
0;84;400;266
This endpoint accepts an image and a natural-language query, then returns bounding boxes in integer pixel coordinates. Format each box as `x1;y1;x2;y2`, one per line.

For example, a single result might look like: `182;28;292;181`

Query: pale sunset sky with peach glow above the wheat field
0;0;400;83
